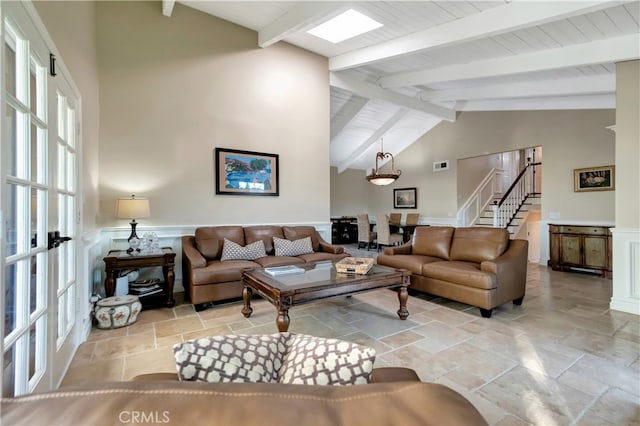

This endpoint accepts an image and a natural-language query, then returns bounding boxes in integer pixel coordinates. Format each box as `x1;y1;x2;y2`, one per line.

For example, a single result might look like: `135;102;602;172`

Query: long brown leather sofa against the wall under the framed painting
182;225;350;310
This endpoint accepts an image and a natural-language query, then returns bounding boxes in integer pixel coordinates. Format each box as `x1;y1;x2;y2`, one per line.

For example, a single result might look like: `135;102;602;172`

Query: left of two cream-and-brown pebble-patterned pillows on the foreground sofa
173;333;289;383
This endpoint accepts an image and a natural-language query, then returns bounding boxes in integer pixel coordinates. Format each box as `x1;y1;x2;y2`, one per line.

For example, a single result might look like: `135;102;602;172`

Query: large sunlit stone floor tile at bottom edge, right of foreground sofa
477;367;593;425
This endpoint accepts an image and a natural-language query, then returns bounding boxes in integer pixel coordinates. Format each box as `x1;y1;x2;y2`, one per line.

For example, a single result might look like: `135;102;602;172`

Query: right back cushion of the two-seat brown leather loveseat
451;227;509;263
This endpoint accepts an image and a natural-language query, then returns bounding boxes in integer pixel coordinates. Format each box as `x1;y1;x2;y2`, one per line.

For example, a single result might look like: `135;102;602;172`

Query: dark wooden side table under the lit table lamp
103;247;176;308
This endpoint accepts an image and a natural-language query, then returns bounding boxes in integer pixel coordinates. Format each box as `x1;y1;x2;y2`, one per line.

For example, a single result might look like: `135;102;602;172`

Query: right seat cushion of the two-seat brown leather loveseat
421;260;497;290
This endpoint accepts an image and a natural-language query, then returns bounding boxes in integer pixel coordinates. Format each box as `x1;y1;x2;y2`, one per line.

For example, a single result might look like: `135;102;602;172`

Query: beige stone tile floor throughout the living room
62;245;640;425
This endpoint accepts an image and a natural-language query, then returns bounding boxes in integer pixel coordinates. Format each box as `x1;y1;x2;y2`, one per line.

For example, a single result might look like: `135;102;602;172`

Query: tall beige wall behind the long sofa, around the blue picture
97;2;329;226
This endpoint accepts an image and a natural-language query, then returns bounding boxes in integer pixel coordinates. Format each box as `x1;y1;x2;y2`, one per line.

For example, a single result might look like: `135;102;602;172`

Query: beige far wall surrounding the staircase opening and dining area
332;110;616;224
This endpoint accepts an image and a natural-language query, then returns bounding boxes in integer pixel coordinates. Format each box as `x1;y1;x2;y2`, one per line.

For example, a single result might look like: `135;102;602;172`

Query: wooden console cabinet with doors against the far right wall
549;224;612;278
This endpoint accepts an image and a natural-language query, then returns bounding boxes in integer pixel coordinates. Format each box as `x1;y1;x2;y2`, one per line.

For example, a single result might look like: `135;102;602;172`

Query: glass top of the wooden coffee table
245;261;398;290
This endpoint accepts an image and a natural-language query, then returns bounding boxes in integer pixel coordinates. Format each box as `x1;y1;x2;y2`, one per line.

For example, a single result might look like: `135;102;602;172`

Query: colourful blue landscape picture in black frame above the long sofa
215;148;280;196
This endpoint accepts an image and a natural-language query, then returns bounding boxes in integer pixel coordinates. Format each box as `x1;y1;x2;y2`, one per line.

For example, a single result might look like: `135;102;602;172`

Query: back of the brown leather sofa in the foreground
0;368;487;426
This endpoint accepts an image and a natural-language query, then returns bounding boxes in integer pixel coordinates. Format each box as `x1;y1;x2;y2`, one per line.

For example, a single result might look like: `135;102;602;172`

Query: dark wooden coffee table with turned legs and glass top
242;262;411;332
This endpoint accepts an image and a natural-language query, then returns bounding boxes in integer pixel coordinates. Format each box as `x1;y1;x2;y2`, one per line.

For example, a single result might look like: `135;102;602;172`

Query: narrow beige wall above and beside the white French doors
34;1;100;231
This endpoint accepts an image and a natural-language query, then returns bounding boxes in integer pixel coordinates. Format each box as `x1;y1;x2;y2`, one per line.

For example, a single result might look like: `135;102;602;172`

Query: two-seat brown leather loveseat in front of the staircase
377;226;529;318
